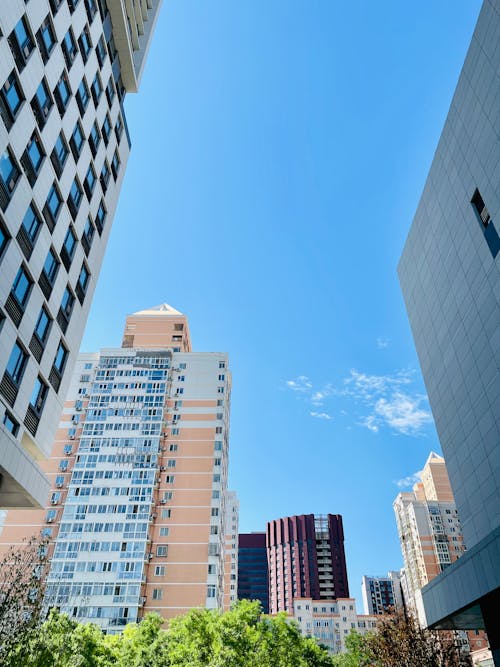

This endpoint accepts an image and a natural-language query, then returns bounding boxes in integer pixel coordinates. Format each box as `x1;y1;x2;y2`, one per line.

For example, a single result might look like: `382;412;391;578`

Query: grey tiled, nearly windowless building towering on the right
399;0;500;665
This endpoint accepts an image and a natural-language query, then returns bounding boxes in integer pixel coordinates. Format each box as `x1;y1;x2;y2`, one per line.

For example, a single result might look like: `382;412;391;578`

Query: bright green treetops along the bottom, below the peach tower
3;600;334;667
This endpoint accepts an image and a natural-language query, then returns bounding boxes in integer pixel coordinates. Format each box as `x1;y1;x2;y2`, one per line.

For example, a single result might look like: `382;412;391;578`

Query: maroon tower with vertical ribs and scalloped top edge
266;514;349;614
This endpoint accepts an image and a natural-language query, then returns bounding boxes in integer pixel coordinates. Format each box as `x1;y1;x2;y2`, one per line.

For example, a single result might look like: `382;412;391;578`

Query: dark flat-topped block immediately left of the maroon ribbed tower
238;533;269;614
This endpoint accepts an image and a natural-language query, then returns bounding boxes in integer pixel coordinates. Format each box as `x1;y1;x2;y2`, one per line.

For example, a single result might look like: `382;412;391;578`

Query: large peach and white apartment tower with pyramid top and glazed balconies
0;304;233;632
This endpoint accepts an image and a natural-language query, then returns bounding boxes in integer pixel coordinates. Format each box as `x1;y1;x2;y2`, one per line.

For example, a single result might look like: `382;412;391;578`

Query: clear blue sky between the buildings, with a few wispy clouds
82;0;480;607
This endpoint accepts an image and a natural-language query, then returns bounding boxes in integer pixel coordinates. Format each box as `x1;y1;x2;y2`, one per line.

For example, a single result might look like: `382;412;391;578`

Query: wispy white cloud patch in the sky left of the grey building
285;368;432;436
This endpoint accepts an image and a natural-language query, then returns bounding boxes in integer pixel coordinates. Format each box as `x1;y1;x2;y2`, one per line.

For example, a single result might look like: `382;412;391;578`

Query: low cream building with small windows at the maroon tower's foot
293;598;379;654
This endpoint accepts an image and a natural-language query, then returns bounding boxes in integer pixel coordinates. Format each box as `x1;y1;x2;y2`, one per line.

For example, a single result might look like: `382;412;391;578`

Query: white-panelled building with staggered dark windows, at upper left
0;0;160;507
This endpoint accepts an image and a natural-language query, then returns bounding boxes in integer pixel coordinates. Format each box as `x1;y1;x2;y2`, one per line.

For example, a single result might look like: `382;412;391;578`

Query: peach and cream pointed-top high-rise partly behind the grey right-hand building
394;452;465;611
